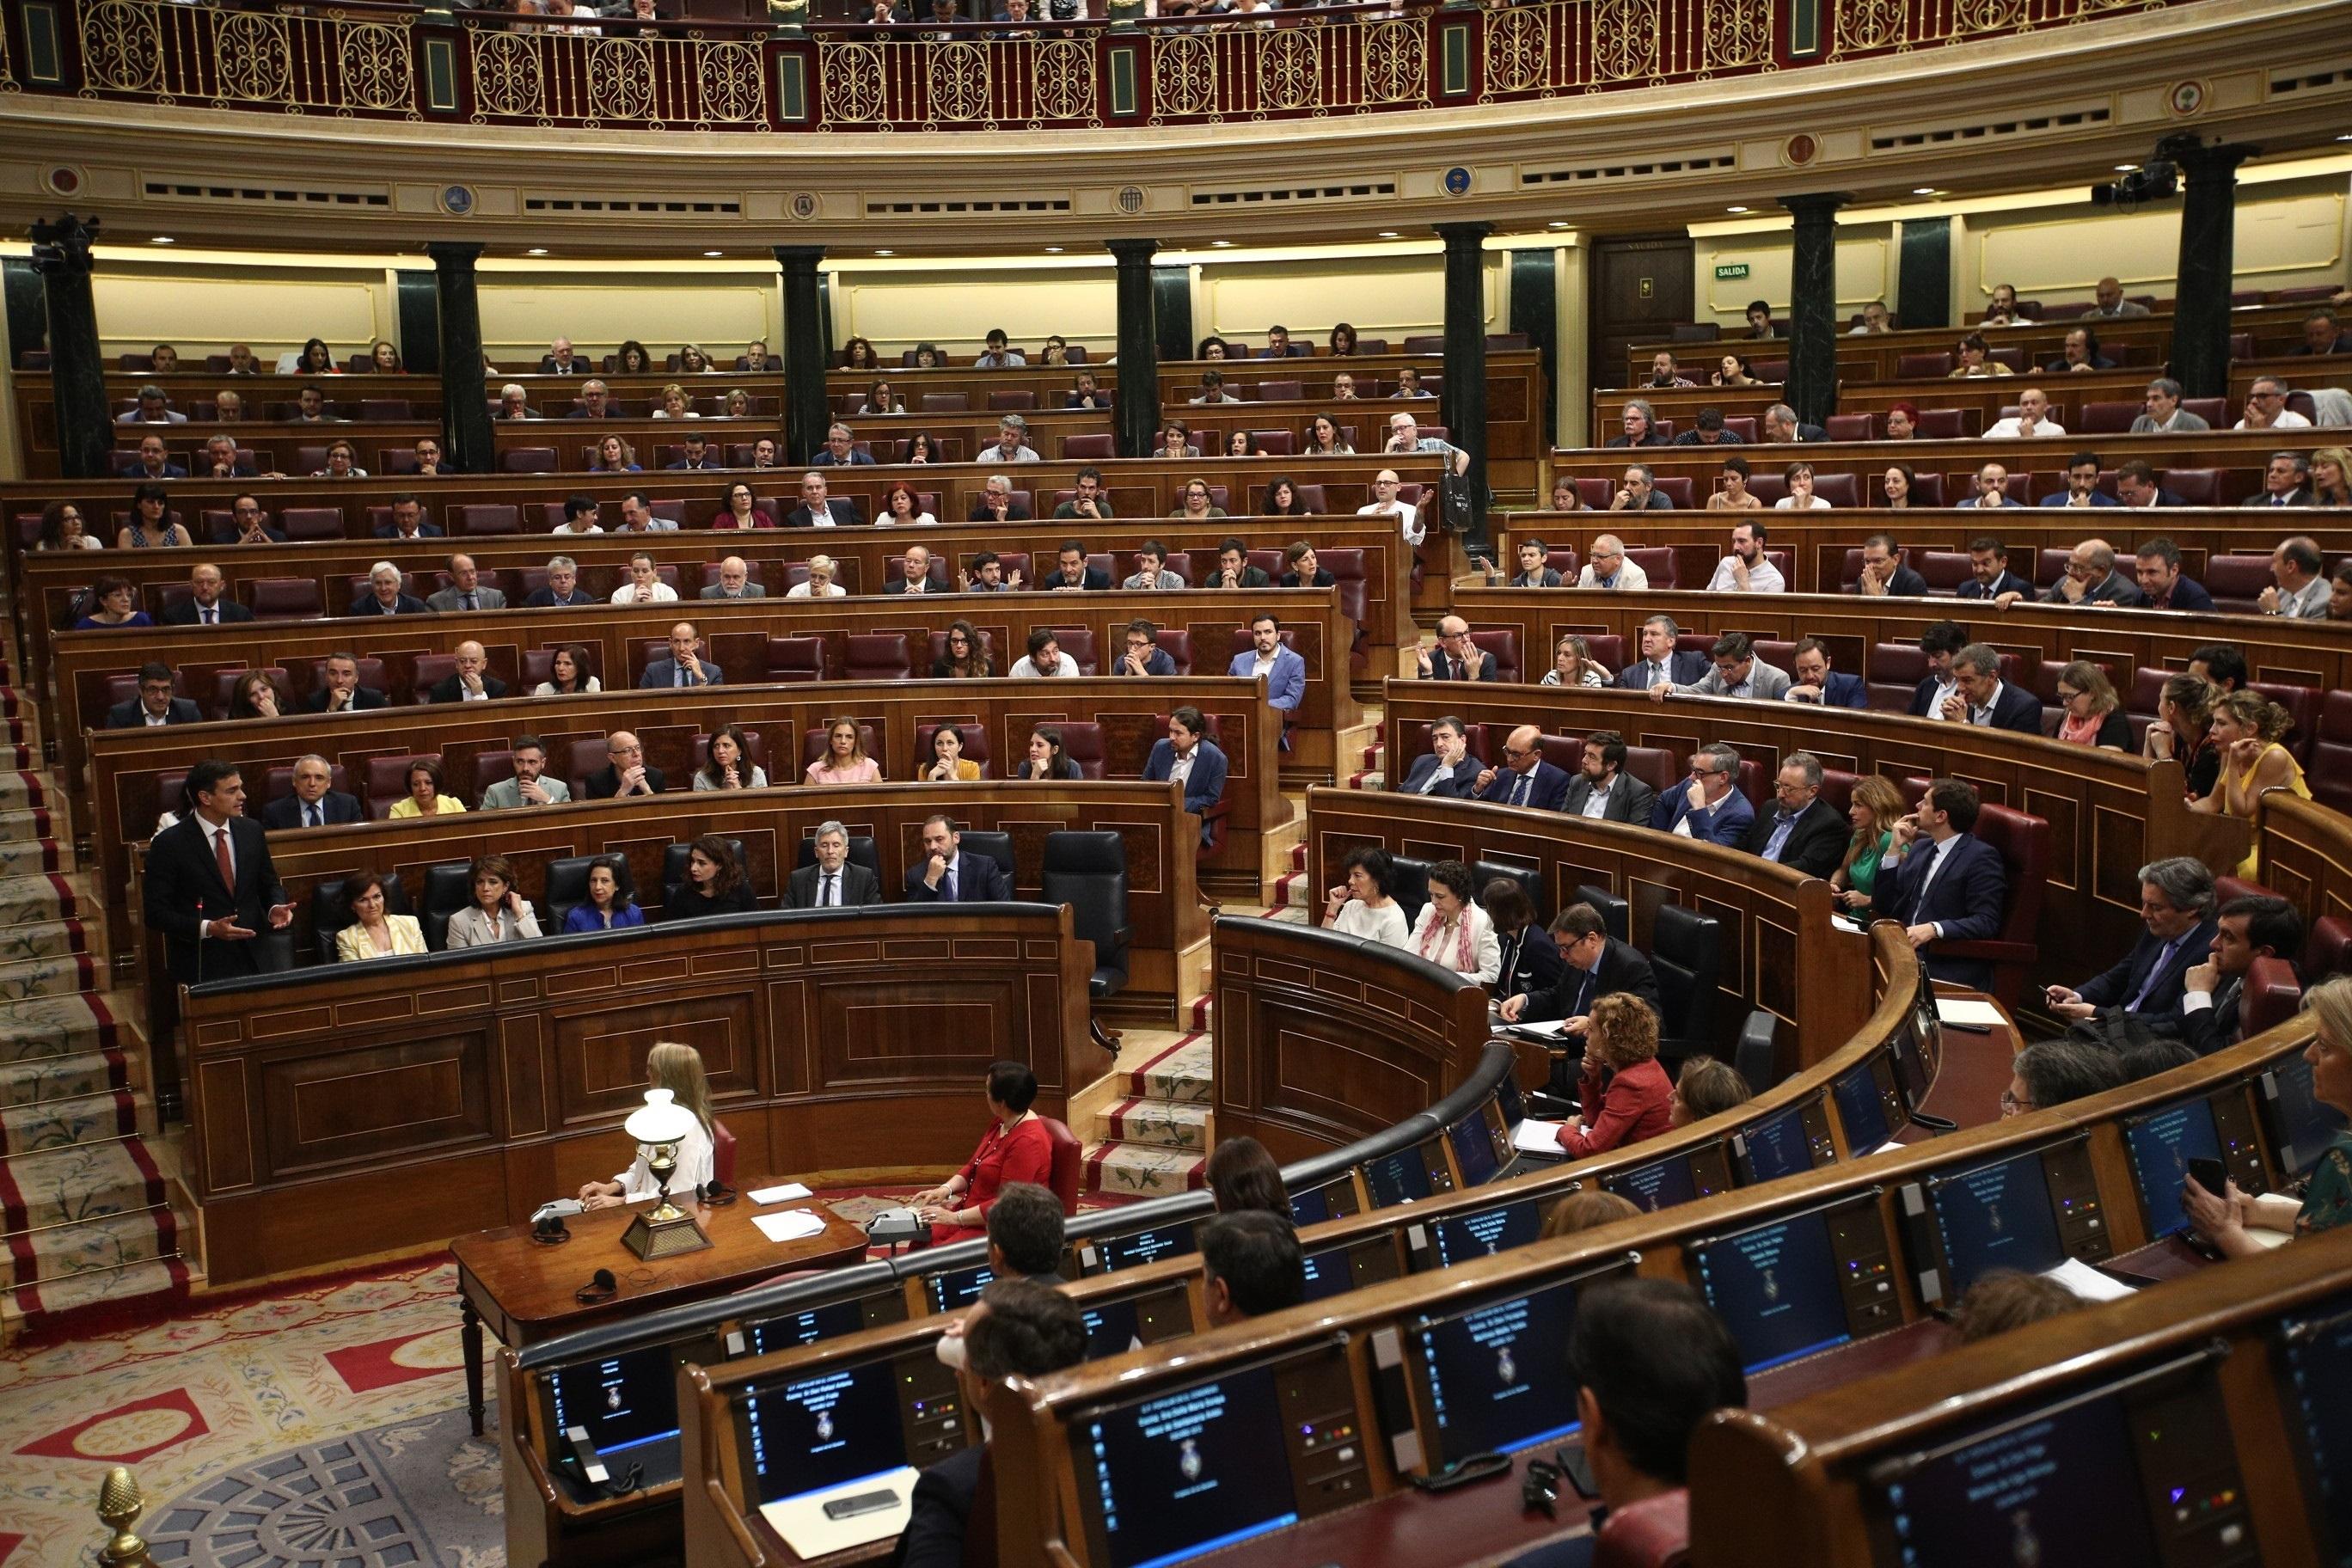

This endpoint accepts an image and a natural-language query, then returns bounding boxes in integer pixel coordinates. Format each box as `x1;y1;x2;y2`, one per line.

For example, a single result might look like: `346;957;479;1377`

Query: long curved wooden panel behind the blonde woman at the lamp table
183;903;1108;1283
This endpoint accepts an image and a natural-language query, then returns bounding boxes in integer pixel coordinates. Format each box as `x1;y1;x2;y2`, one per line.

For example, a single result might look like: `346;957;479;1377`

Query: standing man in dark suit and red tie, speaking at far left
146;759;294;985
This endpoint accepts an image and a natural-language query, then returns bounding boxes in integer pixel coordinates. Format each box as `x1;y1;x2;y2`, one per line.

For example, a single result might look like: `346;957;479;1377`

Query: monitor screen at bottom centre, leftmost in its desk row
1073;1366;1298;1568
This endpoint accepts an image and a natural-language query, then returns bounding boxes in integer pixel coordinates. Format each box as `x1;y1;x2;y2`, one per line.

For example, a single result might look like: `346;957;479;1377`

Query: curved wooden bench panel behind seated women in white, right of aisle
1298;785;1872;1079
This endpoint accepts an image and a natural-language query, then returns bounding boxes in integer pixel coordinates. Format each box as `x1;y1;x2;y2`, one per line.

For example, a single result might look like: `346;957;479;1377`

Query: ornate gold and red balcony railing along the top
0;0;2185;132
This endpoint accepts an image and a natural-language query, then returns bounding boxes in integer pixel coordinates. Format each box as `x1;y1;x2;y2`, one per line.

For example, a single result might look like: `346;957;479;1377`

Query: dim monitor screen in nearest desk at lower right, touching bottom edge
1884;1394;2154;1568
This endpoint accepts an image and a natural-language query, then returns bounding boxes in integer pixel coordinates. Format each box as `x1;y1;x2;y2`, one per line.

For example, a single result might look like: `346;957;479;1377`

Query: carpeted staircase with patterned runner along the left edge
0;639;188;1344
